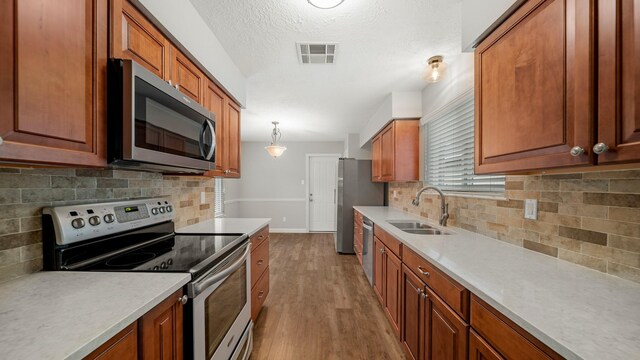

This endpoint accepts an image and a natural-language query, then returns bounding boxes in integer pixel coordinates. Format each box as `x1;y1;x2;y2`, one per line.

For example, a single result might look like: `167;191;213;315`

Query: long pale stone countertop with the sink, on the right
354;206;640;360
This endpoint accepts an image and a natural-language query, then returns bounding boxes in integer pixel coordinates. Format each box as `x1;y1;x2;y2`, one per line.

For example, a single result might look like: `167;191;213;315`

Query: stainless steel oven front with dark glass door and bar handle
189;243;251;360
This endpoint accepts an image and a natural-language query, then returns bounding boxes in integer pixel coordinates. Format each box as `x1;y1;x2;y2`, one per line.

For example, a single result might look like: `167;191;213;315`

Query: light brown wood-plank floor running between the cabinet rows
251;234;404;360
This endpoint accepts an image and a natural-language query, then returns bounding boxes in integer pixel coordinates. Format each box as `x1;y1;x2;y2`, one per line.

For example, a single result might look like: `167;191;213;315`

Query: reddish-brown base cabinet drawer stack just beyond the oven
249;225;269;322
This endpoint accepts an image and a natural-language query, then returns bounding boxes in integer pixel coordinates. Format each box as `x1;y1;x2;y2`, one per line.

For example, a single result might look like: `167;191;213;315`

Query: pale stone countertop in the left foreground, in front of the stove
0;271;191;360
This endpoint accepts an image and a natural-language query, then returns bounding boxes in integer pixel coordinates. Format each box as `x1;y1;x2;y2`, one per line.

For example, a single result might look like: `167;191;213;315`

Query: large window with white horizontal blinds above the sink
423;92;504;193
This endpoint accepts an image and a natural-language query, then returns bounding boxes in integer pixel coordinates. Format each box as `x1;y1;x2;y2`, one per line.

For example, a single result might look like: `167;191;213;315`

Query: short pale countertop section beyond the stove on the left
176;218;271;236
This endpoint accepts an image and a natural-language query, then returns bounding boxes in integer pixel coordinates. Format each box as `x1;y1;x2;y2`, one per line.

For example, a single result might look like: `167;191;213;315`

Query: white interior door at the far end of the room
308;155;338;231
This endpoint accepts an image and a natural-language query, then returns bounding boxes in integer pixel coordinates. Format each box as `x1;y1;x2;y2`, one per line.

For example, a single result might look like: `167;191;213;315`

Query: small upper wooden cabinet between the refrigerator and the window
371;120;420;182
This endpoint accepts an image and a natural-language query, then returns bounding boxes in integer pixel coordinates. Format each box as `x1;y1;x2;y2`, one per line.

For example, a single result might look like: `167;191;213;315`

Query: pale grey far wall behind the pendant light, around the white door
224;141;344;232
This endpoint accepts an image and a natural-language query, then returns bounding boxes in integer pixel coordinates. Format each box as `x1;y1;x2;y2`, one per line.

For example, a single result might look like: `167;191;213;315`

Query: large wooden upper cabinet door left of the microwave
0;0;108;166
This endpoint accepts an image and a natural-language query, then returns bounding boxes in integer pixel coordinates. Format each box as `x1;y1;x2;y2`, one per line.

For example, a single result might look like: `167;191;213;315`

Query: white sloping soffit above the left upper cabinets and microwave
137;0;247;107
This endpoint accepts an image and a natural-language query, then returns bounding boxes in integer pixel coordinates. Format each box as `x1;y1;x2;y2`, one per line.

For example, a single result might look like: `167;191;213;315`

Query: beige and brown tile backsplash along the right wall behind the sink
389;170;640;283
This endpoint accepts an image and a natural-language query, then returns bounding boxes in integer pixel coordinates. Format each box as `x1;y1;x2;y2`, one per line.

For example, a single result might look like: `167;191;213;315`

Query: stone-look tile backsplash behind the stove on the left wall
0;168;214;283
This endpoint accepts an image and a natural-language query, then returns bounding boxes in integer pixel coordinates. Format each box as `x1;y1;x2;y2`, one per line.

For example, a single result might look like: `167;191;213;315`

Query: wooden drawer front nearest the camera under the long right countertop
471;296;562;359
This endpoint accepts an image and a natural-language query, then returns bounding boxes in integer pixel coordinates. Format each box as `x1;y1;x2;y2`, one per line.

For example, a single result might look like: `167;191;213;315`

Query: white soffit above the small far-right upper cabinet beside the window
360;91;422;147
